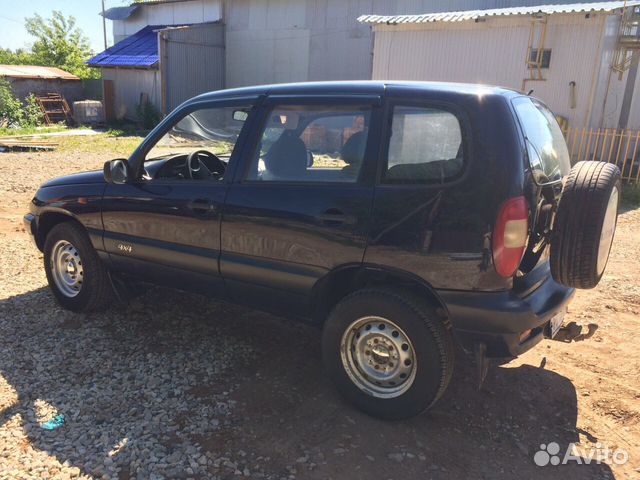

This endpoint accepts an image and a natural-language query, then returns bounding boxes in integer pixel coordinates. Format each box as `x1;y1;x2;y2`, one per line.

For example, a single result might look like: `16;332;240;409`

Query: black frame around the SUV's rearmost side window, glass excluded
376;98;473;188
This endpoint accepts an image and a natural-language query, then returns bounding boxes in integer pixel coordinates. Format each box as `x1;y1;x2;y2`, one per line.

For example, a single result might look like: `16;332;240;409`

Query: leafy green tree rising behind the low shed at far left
25;10;100;78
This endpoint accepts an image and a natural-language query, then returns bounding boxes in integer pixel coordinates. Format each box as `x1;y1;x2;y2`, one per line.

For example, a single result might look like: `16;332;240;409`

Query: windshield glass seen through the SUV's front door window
146;107;249;160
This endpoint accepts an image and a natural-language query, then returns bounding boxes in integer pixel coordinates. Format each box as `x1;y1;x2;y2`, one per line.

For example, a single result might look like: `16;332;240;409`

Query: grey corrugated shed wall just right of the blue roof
160;23;225;113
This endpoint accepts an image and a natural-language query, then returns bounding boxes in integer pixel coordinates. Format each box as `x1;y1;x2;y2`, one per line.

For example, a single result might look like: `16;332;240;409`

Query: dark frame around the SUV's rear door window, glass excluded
237;99;381;187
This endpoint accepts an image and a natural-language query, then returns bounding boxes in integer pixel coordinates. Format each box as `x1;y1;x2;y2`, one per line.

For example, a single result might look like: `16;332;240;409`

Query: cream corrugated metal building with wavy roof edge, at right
359;1;640;129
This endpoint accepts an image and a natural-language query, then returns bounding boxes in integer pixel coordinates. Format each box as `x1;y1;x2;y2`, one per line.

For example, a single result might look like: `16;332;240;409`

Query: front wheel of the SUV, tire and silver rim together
44;222;114;312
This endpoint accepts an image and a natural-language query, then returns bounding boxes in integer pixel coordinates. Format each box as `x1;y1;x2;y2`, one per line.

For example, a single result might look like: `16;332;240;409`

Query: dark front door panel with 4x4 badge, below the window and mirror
102;181;227;284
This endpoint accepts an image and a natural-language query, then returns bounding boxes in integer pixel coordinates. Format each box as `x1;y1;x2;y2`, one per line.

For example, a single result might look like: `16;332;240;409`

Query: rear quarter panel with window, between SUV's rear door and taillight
365;91;503;290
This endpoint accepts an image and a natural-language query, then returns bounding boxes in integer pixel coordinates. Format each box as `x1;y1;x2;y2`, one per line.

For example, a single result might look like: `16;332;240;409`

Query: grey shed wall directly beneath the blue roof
102;68;161;120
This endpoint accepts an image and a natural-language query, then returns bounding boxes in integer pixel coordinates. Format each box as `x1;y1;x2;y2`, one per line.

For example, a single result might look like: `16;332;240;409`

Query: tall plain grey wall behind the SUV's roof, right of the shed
225;0;604;87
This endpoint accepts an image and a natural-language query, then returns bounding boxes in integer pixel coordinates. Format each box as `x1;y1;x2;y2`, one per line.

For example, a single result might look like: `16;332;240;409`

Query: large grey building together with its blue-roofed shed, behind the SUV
90;0;616;118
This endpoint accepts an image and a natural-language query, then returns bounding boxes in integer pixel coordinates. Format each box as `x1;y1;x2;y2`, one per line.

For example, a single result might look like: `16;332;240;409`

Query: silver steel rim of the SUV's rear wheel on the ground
340;316;416;398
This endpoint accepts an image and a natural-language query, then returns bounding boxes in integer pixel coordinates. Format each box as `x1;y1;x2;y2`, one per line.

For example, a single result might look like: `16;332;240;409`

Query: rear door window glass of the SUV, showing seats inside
246;105;371;183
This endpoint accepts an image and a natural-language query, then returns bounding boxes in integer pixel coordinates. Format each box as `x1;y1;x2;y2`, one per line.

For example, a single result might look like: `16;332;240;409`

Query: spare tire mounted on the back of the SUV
550;162;620;288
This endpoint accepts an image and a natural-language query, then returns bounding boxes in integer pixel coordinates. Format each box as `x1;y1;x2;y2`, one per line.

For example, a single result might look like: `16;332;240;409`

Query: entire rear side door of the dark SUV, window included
220;96;381;315
